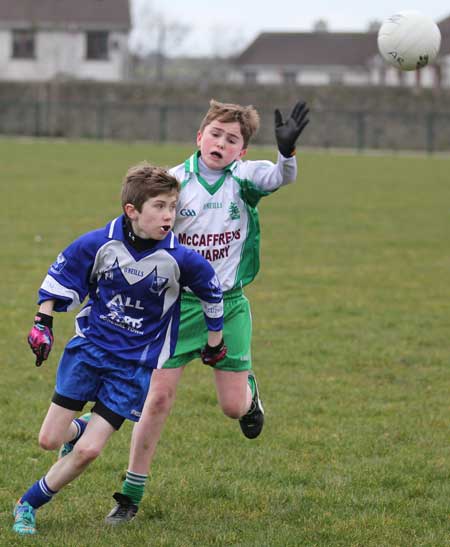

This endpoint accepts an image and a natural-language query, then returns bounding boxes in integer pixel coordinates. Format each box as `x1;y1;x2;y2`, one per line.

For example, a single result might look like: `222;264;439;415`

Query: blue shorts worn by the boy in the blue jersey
53;336;153;429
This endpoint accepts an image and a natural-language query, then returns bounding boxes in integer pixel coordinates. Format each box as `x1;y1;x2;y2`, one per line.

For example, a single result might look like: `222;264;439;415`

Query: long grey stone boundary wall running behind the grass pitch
0;81;450;152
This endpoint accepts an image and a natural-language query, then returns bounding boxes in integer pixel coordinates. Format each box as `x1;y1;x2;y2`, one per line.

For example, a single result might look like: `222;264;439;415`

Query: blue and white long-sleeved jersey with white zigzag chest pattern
38;215;223;368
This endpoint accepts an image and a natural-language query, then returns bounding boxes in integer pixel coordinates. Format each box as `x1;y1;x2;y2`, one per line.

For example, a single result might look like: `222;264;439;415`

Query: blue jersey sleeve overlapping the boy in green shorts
181;249;223;331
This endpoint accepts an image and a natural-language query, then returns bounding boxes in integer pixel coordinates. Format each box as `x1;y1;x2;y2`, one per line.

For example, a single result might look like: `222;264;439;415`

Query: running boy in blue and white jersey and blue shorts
13;163;226;534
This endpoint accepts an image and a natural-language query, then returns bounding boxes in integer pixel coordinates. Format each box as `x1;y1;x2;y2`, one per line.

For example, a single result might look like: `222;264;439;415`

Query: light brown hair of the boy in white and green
200;99;259;148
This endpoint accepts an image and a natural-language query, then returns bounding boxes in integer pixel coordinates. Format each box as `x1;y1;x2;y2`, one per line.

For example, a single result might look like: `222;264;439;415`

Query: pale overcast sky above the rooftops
130;0;450;56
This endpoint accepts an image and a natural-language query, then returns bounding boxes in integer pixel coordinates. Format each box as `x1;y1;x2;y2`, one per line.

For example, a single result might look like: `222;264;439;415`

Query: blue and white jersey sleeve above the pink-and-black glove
38;232;98;312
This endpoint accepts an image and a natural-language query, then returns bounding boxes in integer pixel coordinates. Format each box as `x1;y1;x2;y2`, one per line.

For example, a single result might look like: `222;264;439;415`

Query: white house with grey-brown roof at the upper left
0;0;131;81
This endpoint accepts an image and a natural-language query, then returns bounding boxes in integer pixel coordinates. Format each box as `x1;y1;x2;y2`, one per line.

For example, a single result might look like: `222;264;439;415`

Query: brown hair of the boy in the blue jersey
122;161;180;212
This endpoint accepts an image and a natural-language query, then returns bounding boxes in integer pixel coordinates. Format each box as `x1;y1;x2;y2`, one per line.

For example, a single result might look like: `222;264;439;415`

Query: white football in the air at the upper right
378;11;441;70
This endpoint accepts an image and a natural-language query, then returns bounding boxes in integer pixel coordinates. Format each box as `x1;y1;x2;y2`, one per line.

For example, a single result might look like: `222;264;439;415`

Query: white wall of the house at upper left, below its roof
0;30;127;81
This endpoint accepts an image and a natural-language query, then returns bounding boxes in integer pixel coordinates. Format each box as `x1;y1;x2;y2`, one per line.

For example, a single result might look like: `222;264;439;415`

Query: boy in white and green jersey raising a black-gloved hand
106;101;309;524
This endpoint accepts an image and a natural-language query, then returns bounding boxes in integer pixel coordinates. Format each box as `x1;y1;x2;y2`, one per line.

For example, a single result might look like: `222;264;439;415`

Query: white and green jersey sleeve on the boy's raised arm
236;153;297;207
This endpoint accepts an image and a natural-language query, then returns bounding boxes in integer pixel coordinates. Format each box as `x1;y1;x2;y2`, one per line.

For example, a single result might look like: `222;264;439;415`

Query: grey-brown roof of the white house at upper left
0;0;131;32
